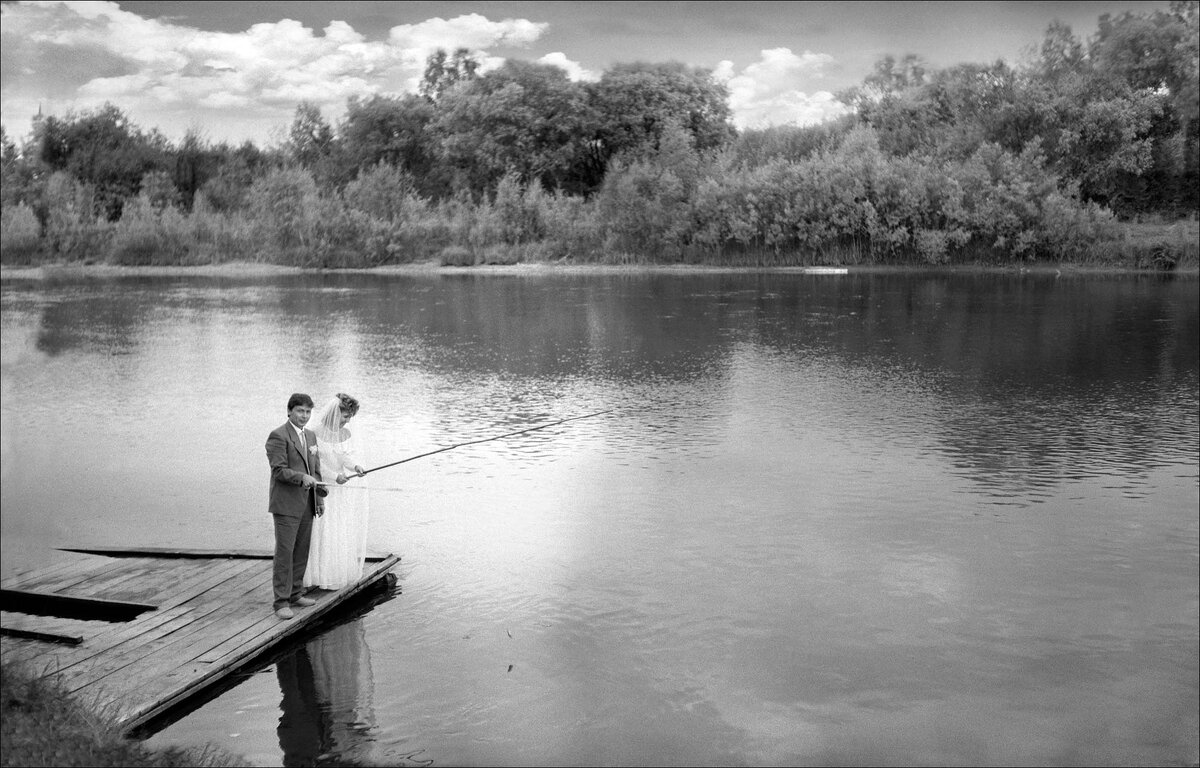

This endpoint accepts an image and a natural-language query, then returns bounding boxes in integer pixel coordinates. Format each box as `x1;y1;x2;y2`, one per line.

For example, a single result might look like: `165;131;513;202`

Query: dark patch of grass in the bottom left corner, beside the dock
0;659;250;768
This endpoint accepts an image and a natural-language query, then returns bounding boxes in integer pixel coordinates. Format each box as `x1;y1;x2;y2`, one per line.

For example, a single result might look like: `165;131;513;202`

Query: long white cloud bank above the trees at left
0;1;549;140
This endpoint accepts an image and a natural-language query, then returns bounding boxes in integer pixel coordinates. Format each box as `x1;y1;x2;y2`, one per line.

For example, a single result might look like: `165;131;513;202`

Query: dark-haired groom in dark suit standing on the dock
266;392;329;619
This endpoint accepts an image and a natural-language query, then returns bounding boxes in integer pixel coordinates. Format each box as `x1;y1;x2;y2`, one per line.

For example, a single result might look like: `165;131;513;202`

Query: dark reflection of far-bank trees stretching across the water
23;271;1200;499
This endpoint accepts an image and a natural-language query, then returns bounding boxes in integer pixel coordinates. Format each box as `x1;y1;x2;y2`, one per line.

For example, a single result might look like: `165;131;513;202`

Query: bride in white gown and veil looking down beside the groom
304;392;367;589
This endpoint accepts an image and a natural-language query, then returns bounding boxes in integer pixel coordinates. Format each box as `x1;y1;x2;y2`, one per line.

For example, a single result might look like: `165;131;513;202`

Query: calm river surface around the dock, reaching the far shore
0;269;1200;766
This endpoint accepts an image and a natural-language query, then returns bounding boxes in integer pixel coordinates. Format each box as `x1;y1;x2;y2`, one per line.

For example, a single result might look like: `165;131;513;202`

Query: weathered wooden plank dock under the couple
0;548;400;733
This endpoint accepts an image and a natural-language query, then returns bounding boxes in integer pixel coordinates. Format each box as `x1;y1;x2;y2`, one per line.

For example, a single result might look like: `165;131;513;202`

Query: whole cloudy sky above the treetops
0;0;1169;146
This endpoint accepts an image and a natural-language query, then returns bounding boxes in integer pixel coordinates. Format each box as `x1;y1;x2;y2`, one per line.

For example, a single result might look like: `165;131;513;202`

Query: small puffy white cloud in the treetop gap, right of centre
713;48;846;128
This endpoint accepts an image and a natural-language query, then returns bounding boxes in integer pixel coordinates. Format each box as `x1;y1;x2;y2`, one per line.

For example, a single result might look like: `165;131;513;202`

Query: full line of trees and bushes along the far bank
0;0;1200;266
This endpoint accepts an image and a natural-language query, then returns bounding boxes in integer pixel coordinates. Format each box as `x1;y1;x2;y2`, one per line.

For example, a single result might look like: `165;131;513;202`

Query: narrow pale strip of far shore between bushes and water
0;262;1200;281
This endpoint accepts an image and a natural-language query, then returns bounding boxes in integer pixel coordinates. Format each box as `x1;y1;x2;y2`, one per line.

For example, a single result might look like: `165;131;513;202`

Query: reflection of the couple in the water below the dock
275;619;393;766
